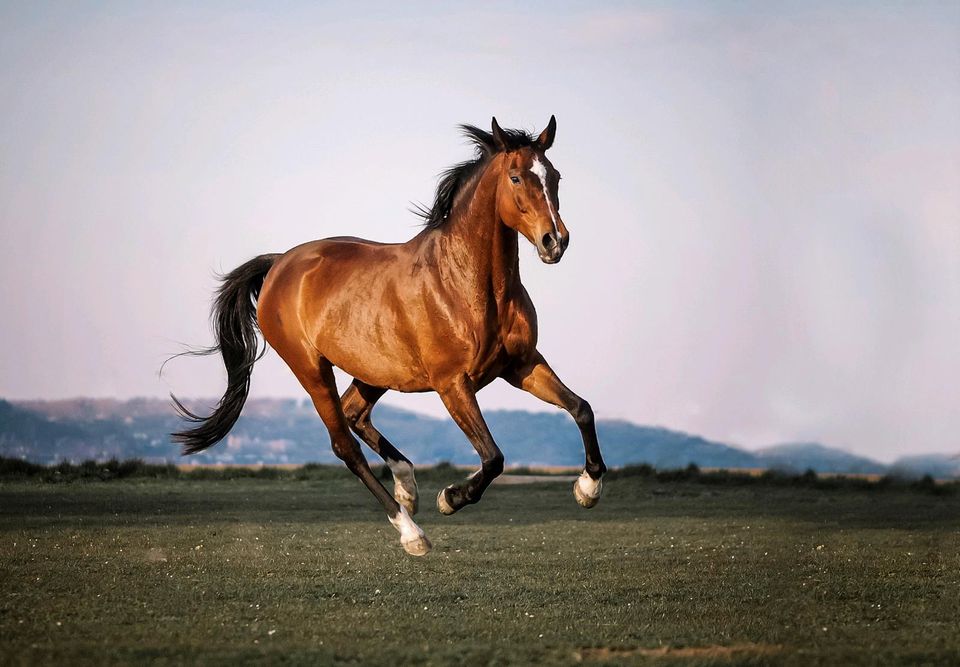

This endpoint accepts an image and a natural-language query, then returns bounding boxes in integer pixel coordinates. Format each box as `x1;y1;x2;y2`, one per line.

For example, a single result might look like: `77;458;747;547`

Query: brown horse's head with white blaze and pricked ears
493;116;570;264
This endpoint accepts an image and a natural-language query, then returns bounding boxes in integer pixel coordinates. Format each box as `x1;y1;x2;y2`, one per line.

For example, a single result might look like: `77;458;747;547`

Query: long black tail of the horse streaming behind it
170;255;280;454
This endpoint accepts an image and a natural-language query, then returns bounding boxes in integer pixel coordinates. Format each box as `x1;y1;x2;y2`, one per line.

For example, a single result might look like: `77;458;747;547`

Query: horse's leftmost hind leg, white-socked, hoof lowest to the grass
295;359;431;556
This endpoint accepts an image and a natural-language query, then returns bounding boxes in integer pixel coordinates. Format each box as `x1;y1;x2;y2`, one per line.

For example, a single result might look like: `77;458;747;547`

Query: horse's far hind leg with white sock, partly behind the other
340;380;419;514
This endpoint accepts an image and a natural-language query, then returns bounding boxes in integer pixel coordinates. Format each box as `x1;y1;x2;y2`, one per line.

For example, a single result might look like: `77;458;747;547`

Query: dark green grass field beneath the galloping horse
0;471;960;665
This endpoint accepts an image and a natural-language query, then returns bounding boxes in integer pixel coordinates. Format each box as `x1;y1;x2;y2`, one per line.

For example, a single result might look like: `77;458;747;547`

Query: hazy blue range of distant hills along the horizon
0;398;960;476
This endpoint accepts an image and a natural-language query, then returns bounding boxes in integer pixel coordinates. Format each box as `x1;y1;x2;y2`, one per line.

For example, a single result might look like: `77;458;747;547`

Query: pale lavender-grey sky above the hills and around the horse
0;1;960;461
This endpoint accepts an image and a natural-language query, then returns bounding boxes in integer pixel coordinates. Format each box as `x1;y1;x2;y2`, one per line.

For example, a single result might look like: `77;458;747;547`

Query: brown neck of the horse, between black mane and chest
441;161;520;301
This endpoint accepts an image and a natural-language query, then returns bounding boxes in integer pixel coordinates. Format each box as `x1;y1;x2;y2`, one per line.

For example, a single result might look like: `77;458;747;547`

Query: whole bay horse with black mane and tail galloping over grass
173;116;606;556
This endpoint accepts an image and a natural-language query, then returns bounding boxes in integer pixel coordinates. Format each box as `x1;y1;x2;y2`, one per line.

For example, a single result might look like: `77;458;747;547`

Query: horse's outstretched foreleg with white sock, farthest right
503;352;607;507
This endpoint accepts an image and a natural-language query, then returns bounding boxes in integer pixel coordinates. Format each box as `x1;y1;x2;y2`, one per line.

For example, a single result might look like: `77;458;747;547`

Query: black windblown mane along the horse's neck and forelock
413;125;537;229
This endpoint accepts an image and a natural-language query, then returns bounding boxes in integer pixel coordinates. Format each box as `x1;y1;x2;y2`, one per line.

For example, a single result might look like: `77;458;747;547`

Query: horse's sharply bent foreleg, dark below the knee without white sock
437;376;503;514
